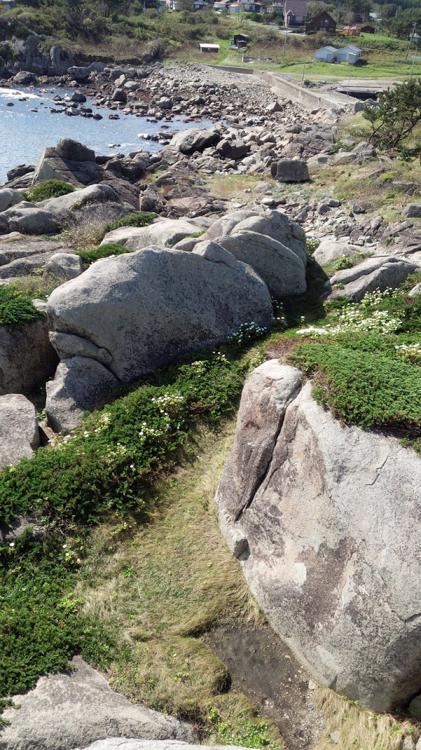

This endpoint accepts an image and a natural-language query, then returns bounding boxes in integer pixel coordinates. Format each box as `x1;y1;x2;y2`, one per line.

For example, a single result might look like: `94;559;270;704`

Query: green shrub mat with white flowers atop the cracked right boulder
290;277;421;440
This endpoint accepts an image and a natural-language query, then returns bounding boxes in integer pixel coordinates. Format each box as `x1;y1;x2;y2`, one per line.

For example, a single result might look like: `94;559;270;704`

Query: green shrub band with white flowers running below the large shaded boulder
0;354;244;529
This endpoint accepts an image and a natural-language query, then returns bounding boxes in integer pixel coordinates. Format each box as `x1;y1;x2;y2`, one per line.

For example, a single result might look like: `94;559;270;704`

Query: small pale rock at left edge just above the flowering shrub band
0;393;39;469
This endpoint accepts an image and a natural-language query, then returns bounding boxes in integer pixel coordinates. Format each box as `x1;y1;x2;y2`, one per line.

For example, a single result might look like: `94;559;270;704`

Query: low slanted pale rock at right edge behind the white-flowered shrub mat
330;255;419;302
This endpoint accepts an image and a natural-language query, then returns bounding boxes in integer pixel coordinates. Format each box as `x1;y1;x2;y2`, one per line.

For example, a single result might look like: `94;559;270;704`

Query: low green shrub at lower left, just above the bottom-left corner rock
0;540;112;700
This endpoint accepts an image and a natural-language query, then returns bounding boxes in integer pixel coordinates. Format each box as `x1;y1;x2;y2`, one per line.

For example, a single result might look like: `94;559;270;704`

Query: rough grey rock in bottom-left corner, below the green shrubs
0;657;195;750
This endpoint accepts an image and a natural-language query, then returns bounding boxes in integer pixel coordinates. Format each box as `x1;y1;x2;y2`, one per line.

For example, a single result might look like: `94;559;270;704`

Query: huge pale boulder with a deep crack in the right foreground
216;360;421;711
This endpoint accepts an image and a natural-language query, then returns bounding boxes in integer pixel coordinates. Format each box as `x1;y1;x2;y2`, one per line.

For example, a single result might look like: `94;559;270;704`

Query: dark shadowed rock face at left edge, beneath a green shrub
0;319;57;395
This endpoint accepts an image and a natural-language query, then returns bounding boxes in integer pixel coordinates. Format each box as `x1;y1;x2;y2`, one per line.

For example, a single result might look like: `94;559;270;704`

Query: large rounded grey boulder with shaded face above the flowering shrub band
47;247;272;432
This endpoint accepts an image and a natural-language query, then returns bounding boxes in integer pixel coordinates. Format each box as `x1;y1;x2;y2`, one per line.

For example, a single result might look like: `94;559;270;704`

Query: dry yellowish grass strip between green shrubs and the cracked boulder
78;421;280;747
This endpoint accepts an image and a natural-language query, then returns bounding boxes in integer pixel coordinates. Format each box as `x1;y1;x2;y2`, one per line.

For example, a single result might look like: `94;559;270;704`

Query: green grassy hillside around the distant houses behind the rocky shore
0;3;421;79
